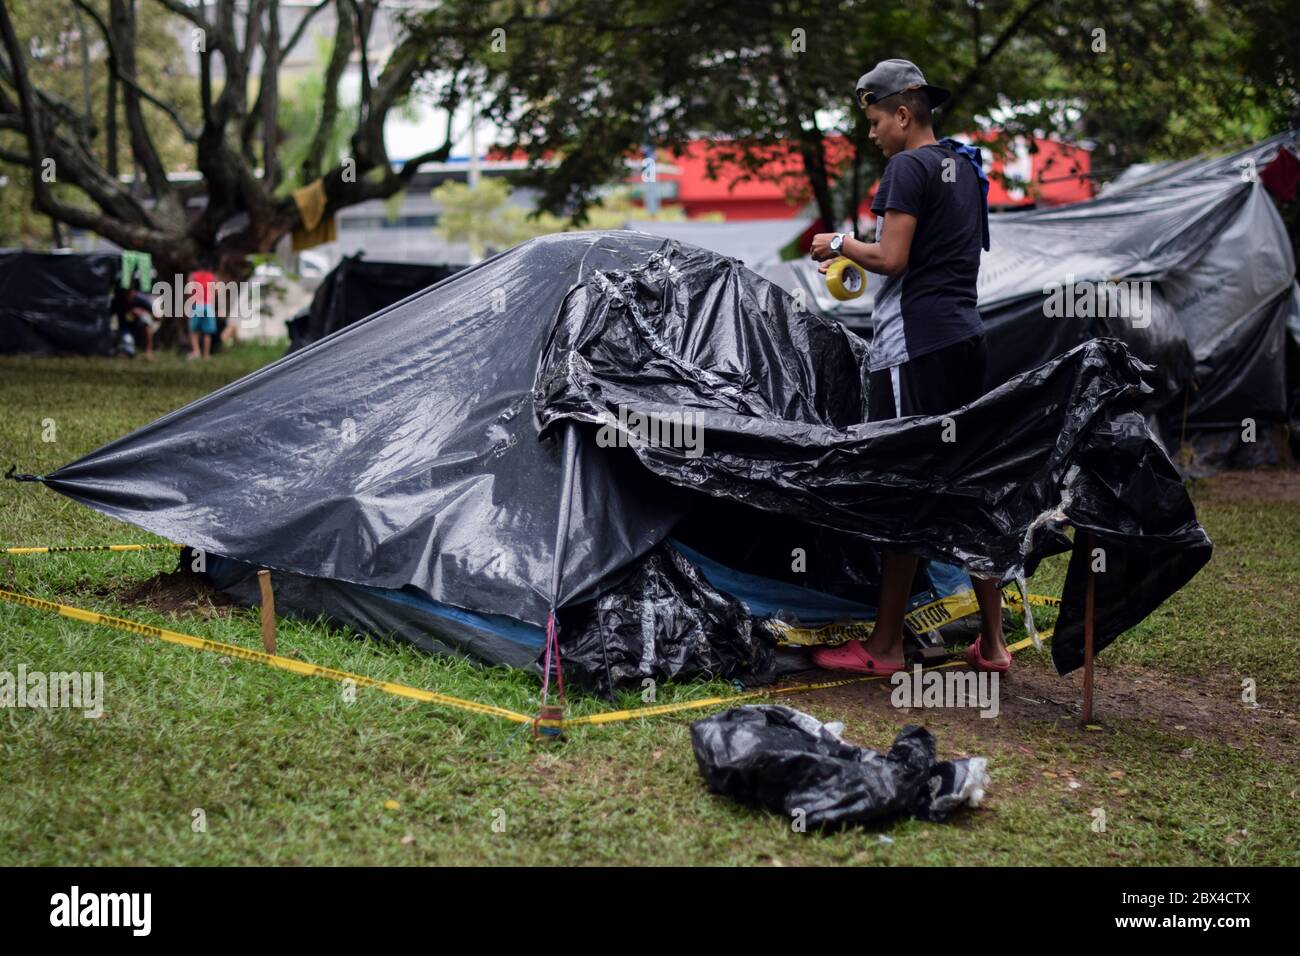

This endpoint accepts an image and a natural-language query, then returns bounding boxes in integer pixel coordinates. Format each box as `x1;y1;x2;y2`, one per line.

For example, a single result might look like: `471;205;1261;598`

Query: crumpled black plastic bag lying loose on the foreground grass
690;704;988;829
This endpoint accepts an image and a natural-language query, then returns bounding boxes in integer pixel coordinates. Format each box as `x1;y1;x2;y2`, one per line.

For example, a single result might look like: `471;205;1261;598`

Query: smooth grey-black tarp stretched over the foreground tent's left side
48;233;685;634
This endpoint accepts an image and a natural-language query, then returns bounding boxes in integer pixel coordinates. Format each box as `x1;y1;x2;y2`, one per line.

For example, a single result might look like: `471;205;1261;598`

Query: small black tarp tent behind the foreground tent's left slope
289;252;463;351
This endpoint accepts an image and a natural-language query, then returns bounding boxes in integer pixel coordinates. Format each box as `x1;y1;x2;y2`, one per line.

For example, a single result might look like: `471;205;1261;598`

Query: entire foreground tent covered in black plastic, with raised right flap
27;232;1210;687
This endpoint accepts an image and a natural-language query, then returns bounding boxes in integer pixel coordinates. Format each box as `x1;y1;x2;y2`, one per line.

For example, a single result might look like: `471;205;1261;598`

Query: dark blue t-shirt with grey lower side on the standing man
871;143;985;372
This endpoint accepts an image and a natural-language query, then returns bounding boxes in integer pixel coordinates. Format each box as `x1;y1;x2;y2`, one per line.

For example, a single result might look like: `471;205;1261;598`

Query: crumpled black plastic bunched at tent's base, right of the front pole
562;544;776;697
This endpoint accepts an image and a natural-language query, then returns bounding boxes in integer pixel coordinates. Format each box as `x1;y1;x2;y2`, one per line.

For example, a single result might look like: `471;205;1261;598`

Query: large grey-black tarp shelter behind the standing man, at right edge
763;133;1300;471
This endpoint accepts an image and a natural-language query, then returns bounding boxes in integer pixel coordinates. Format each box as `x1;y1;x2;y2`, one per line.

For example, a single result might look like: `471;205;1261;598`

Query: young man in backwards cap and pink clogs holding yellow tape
813;60;1011;674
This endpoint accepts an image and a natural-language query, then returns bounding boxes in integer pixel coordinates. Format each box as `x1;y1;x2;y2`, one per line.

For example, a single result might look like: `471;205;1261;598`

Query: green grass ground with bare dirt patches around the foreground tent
0;347;1300;865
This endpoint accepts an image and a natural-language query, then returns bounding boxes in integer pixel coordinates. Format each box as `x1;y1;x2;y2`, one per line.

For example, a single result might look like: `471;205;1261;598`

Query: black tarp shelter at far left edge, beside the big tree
0;248;122;355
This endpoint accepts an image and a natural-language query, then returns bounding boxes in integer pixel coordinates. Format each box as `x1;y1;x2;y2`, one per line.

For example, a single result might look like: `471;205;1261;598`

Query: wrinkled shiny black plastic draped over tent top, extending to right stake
537;247;1213;674
